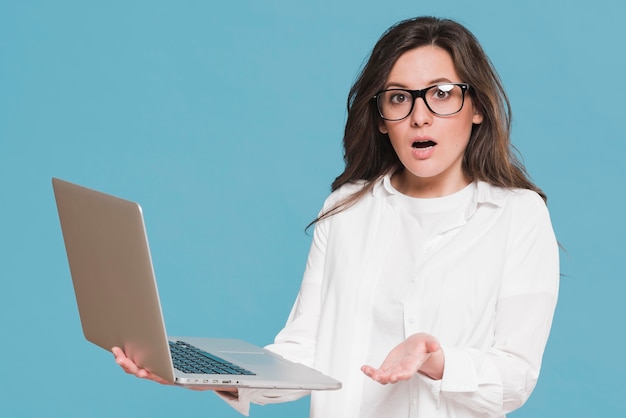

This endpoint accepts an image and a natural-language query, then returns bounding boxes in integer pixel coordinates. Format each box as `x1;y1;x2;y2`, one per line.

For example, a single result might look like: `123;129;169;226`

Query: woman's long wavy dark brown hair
311;17;547;224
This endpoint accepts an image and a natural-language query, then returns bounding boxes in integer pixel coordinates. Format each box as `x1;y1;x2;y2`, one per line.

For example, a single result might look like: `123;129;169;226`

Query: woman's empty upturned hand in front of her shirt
361;333;444;385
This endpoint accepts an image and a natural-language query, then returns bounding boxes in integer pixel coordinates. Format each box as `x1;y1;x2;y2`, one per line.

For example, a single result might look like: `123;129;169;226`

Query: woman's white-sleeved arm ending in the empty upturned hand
363;192;559;415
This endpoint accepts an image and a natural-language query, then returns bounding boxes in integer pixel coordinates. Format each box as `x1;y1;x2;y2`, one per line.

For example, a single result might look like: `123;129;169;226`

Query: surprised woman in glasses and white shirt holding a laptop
114;17;559;418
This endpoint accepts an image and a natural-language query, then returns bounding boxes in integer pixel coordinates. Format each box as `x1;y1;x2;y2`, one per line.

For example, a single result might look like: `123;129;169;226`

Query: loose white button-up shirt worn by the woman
219;176;559;418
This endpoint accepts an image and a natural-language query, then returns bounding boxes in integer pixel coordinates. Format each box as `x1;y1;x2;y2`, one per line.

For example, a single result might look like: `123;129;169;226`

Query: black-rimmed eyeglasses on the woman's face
373;83;470;121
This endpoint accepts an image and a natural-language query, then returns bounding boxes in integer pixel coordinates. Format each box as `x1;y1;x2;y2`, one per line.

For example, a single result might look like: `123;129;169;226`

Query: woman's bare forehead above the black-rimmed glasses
387;45;462;89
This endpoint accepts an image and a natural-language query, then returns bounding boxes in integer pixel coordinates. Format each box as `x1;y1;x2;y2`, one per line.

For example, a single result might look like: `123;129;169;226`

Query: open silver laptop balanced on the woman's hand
52;178;341;390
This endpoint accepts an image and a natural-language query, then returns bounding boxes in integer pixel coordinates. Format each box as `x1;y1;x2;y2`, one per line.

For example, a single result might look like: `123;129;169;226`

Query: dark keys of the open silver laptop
170;341;255;376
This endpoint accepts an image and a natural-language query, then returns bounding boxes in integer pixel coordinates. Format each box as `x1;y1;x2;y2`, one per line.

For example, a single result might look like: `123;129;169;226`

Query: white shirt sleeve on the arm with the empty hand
420;194;559;416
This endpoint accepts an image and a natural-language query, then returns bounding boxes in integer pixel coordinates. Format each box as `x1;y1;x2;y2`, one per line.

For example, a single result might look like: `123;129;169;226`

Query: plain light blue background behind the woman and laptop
0;0;626;418
